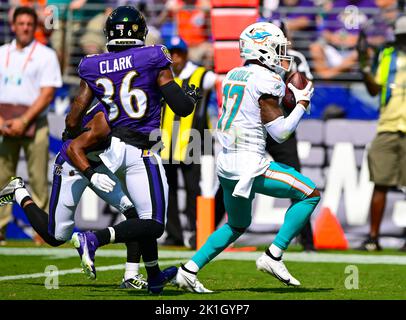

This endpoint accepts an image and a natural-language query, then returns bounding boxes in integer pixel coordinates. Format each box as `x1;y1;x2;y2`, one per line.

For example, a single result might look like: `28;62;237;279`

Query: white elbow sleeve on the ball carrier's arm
265;104;305;143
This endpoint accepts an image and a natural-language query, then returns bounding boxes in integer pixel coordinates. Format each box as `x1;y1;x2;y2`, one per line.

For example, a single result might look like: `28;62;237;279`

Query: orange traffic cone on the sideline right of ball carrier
313;207;348;250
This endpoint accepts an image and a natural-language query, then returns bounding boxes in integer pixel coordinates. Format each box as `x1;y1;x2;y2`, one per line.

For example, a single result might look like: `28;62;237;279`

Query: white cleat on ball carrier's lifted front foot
257;253;300;287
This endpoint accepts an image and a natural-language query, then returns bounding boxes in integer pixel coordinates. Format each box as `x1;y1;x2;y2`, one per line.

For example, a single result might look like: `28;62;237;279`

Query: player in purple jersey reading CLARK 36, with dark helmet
65;6;199;293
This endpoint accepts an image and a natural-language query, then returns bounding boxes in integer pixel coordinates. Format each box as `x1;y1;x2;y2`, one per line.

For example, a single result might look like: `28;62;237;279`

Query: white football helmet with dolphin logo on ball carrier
240;22;293;73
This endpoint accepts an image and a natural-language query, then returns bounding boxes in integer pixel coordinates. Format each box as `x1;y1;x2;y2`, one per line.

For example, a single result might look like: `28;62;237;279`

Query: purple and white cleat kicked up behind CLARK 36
71;231;99;280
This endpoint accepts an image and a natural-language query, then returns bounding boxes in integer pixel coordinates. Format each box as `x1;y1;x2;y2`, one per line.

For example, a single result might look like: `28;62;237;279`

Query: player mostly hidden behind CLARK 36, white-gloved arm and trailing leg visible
0;103;147;289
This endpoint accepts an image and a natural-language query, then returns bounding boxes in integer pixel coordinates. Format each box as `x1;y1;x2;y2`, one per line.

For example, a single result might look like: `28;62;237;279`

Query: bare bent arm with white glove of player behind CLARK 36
66;112;115;192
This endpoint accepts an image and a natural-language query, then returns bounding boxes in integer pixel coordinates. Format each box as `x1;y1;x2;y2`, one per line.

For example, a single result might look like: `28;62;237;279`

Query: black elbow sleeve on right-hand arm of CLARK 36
159;81;195;117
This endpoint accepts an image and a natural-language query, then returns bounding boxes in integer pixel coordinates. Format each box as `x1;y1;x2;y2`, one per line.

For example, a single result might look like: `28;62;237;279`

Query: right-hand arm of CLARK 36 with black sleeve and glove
157;68;199;117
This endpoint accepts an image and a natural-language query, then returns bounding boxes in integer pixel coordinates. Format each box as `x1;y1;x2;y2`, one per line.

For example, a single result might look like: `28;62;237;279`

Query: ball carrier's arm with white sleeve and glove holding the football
258;82;313;143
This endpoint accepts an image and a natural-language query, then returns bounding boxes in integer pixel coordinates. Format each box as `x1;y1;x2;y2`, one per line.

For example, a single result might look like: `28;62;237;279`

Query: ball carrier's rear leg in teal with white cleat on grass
176;177;254;293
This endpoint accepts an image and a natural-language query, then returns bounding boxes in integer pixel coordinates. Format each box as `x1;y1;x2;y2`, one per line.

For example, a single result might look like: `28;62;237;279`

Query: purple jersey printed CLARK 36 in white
78;45;172;135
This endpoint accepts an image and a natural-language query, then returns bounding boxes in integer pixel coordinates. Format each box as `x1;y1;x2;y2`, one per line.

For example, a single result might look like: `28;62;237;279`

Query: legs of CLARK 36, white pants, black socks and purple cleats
72;146;177;293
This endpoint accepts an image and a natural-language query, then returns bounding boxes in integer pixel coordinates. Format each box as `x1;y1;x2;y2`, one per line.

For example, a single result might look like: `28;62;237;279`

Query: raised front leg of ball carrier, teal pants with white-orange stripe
252;162;320;286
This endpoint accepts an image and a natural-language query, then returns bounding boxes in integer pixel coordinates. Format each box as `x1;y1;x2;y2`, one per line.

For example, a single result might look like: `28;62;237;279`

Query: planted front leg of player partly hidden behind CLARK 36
89;164;147;289
